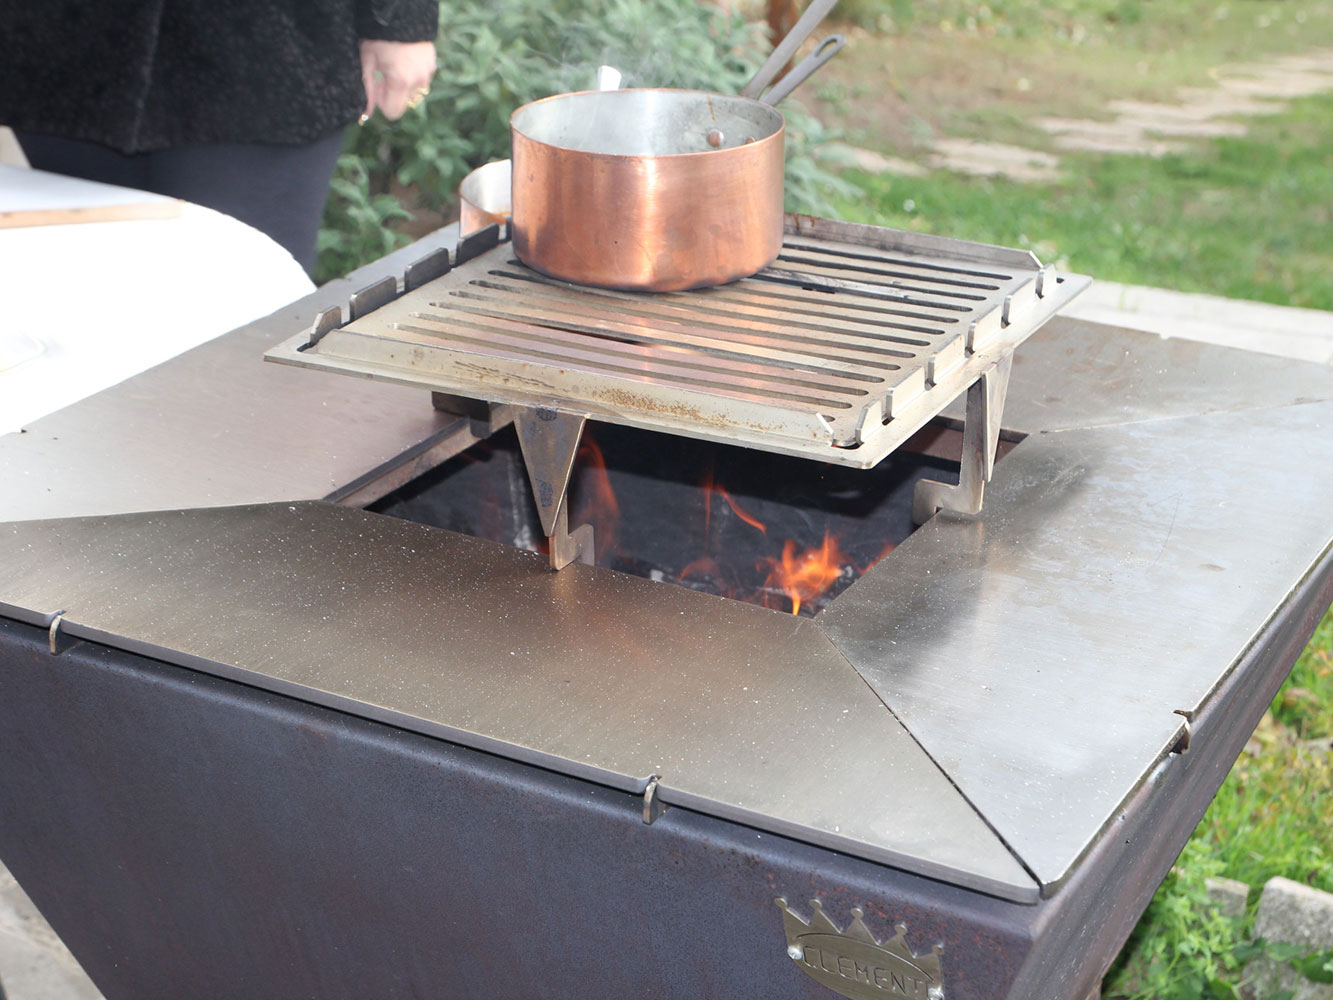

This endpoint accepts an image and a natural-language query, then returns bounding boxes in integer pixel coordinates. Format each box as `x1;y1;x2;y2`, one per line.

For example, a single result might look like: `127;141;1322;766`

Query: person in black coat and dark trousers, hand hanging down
0;0;439;271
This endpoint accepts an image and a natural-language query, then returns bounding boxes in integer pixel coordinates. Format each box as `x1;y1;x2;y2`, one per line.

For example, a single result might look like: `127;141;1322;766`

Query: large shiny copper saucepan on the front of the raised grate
509;25;844;292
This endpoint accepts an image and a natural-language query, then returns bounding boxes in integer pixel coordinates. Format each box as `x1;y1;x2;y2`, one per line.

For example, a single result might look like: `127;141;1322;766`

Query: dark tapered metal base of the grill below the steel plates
0;541;1333;1000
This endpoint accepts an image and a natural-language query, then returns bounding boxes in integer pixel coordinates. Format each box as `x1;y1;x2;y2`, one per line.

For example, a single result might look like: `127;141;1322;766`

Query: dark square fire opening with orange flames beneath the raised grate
371;424;1008;616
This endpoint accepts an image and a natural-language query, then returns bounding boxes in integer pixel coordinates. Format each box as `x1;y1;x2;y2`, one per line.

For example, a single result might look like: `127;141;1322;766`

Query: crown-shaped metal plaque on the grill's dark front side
774;899;944;1000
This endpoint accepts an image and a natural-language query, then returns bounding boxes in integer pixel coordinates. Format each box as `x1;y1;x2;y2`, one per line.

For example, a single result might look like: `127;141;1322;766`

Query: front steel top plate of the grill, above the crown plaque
0;503;1037;901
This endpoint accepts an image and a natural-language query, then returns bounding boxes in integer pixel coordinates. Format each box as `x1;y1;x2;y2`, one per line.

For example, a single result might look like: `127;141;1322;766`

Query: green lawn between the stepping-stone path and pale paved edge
838;95;1333;309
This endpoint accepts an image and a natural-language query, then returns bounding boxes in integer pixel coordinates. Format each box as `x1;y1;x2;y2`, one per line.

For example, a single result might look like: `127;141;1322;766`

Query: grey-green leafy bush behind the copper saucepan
319;0;848;280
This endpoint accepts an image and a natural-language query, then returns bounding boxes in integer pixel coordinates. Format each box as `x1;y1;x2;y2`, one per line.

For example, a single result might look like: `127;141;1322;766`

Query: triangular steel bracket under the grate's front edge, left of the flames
513;407;593;569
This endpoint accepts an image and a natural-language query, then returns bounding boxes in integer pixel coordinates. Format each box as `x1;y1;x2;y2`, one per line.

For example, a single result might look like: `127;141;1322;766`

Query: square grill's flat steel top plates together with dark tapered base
0;222;1333;1000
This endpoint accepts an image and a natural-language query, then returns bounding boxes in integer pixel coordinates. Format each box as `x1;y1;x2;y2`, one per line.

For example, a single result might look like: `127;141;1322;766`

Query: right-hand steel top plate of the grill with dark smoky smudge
818;403;1333;888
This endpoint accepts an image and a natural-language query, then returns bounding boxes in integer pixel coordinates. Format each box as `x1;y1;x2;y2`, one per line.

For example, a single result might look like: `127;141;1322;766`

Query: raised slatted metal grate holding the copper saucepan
271;217;1086;467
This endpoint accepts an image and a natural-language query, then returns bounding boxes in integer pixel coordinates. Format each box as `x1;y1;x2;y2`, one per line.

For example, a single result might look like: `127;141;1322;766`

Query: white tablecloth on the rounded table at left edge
0;171;313;433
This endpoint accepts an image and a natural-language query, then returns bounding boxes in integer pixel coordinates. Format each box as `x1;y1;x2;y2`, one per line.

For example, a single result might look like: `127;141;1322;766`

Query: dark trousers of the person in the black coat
17;132;343;273
